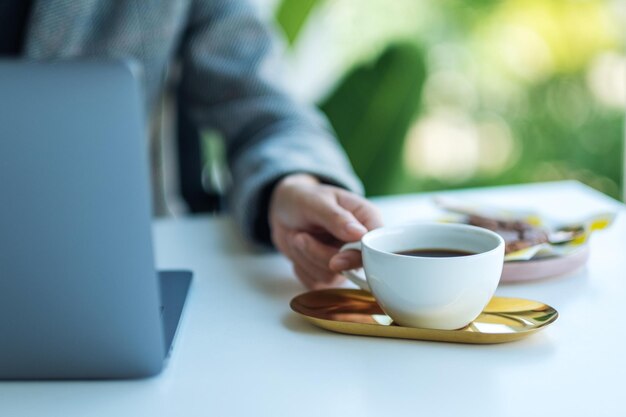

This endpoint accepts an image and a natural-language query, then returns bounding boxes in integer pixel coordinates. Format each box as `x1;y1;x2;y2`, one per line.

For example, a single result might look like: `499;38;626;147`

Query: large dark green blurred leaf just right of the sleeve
321;43;426;195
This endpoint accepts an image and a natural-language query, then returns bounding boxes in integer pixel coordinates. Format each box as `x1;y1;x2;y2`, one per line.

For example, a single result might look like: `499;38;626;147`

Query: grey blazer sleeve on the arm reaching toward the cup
181;0;362;243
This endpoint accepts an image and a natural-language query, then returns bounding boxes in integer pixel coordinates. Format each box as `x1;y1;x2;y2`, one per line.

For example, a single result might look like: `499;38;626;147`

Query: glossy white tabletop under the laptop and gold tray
0;182;626;417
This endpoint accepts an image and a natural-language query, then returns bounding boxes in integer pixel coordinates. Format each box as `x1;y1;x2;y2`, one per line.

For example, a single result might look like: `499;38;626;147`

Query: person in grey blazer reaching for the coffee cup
0;0;381;288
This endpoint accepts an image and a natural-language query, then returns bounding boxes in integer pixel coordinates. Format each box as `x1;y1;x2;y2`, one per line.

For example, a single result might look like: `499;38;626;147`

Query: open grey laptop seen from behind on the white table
0;61;191;379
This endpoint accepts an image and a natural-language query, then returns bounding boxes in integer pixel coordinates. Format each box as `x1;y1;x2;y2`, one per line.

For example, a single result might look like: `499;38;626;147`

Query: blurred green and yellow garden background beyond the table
250;0;626;199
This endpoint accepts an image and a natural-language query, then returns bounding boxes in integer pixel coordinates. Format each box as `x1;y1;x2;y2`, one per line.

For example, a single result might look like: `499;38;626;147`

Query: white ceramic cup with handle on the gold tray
341;223;504;330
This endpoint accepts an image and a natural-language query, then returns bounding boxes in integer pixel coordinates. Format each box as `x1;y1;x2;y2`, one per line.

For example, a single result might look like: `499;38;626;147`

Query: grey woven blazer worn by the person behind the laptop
24;0;362;240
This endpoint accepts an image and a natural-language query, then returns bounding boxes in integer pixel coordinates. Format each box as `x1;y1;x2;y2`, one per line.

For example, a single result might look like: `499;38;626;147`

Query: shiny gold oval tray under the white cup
290;289;559;344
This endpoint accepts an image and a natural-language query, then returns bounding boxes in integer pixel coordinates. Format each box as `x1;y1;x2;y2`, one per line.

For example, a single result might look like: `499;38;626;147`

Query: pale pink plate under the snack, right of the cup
500;246;589;283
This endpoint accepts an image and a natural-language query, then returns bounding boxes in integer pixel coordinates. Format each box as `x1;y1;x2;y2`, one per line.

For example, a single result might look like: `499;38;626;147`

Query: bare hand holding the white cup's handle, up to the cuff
269;174;382;289
